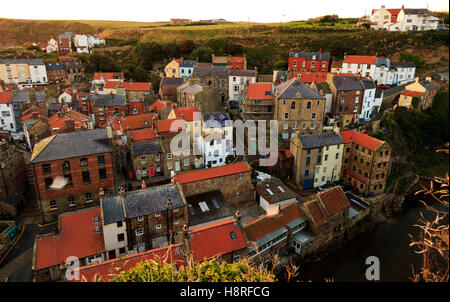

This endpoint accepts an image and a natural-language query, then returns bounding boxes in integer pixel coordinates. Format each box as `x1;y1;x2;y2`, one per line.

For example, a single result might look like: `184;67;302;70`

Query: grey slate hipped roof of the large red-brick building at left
31;129;112;163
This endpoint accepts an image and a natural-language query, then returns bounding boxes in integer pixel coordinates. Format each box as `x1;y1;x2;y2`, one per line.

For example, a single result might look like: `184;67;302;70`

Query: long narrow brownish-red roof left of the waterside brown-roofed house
244;203;303;242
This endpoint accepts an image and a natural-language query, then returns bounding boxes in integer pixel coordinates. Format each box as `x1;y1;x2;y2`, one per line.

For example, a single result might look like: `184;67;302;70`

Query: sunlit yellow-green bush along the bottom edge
95;259;276;282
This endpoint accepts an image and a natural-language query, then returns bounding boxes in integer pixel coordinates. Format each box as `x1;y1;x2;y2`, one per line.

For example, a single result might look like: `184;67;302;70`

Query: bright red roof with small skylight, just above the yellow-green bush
189;220;247;262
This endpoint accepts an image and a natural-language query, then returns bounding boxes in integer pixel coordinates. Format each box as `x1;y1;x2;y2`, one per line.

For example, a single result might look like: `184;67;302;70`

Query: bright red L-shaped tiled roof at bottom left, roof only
36;208;105;270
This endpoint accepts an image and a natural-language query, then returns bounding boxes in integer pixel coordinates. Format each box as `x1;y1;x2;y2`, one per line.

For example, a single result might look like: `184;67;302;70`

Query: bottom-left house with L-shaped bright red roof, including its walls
32;207;105;282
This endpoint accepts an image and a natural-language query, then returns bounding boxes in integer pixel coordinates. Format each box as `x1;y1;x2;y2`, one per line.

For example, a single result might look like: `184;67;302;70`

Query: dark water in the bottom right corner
299;190;444;282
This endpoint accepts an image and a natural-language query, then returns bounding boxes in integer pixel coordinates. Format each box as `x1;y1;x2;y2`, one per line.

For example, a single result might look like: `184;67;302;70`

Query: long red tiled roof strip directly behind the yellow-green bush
71;244;186;282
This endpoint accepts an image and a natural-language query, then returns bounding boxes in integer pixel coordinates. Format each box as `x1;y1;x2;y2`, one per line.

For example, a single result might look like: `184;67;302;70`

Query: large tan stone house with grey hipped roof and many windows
273;79;325;140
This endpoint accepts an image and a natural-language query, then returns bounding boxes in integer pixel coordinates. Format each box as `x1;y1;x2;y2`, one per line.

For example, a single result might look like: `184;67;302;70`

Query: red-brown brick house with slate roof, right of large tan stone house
327;74;364;127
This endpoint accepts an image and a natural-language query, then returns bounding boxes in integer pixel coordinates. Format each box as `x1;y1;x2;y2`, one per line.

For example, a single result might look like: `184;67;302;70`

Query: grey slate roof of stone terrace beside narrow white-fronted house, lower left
123;185;184;218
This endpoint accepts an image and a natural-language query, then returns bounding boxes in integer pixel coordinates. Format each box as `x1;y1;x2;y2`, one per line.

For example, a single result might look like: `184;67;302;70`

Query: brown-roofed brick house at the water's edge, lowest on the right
300;186;350;250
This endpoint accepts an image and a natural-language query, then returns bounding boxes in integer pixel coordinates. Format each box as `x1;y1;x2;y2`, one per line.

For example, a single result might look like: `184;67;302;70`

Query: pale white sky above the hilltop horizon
0;0;449;22
